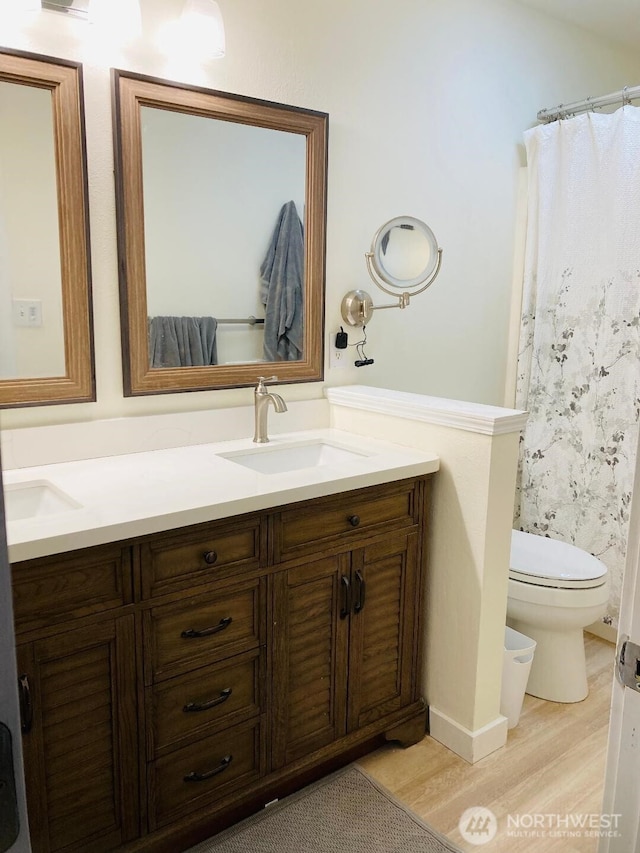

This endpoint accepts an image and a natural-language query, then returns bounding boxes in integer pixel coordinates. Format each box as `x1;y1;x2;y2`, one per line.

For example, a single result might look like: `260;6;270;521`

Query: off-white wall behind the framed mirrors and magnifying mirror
0;0;640;427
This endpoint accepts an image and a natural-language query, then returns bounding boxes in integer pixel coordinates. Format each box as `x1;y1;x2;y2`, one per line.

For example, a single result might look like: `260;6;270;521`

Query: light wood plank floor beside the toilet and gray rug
359;634;615;853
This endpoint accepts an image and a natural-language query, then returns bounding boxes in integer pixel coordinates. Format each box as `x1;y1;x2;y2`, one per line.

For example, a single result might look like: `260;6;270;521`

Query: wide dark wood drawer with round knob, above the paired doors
276;481;416;559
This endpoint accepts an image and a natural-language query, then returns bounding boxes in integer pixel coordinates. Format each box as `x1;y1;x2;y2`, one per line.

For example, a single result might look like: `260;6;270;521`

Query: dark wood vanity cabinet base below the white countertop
13;477;430;853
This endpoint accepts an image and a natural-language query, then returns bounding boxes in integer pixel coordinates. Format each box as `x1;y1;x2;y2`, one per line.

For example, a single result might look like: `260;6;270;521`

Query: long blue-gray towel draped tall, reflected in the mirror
260;201;304;361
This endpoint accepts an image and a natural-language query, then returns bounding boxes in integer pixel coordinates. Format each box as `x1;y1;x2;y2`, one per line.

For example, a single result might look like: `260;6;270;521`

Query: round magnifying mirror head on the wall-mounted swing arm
367;216;440;293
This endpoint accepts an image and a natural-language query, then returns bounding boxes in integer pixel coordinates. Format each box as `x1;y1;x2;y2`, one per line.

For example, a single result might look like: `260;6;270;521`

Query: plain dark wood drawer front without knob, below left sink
12;545;132;633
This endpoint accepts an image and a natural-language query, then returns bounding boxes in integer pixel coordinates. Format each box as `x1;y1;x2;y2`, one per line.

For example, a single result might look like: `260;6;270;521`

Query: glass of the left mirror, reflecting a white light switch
0;82;65;379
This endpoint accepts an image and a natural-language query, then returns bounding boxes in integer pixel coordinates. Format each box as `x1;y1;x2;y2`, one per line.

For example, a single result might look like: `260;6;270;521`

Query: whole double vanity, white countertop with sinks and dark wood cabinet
5;429;439;853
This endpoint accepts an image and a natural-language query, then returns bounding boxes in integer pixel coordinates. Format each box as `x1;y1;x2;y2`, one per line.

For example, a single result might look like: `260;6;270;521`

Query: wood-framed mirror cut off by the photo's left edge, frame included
0;48;95;408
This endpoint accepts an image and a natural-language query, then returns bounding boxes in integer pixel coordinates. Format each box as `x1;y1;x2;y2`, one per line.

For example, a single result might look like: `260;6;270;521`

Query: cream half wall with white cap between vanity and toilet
329;386;522;763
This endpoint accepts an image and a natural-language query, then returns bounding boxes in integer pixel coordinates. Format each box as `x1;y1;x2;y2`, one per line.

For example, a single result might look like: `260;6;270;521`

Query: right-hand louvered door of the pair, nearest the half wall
348;532;421;731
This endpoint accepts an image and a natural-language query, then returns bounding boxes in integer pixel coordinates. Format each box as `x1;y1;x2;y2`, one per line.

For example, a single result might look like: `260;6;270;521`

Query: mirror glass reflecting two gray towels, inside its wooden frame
141;106;306;367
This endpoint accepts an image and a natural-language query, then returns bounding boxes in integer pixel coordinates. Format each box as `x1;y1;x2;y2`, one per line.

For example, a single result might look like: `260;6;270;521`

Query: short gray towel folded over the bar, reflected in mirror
149;317;218;367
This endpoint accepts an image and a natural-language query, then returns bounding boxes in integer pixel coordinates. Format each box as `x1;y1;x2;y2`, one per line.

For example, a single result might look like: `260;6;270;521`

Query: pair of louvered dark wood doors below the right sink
273;531;420;768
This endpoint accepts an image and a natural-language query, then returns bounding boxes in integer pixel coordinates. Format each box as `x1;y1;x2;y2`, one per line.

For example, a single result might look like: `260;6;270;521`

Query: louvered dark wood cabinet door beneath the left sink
18;616;139;853
